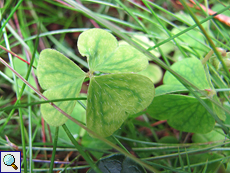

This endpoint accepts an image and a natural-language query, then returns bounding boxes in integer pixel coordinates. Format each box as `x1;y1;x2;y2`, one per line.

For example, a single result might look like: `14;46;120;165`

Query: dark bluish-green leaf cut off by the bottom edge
87;154;146;173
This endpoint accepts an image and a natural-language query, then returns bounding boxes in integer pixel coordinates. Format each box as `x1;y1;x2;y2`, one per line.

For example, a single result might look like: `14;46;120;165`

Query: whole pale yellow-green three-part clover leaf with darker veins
37;29;154;137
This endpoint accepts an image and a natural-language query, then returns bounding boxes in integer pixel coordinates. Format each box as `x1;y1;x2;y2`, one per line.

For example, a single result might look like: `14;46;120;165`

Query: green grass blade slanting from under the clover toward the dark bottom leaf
62;124;102;173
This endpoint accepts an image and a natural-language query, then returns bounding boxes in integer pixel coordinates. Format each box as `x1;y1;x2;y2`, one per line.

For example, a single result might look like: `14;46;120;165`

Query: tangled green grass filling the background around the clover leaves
0;0;230;172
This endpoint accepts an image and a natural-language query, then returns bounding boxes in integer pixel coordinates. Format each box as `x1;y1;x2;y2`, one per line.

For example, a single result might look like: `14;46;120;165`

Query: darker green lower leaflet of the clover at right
147;95;215;133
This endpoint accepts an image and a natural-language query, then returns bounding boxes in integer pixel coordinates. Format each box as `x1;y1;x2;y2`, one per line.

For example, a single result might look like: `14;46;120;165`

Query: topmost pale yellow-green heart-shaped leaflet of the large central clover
78;28;148;73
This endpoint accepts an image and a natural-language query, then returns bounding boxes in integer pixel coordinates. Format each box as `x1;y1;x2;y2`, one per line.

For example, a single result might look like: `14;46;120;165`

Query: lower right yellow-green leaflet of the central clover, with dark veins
86;73;154;137
